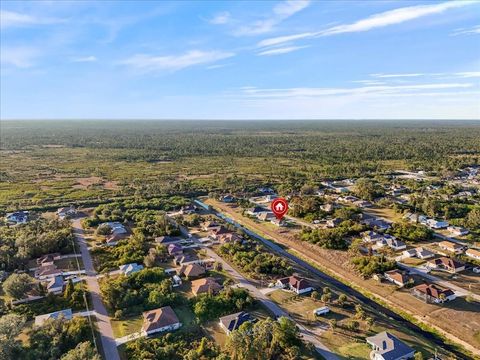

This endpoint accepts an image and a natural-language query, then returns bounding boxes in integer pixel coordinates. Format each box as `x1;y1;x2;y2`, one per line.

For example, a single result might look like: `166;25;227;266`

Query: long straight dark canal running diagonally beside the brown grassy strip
195;200;474;359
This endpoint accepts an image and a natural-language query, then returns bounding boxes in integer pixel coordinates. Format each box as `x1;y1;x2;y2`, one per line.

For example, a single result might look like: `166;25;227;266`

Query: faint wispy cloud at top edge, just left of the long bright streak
235;0;310;36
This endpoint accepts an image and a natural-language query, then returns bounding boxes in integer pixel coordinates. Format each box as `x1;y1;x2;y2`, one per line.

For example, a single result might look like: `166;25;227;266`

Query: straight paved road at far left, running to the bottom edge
73;219;120;360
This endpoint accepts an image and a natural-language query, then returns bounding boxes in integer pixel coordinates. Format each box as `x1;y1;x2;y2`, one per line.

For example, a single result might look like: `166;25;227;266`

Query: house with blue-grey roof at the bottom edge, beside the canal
366;331;415;360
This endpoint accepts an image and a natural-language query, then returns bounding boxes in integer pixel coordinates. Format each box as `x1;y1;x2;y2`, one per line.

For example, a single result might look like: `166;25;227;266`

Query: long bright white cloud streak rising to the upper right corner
258;1;475;47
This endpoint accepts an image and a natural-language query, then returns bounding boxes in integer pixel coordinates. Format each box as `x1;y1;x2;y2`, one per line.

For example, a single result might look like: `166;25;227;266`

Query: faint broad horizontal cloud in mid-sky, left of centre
121;50;235;72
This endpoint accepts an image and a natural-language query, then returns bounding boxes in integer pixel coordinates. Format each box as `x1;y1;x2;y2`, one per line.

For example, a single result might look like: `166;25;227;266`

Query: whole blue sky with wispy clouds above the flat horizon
0;0;480;119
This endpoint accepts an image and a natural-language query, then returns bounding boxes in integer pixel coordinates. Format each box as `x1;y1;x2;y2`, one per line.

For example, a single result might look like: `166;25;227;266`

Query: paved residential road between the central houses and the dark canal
172;215;339;360
